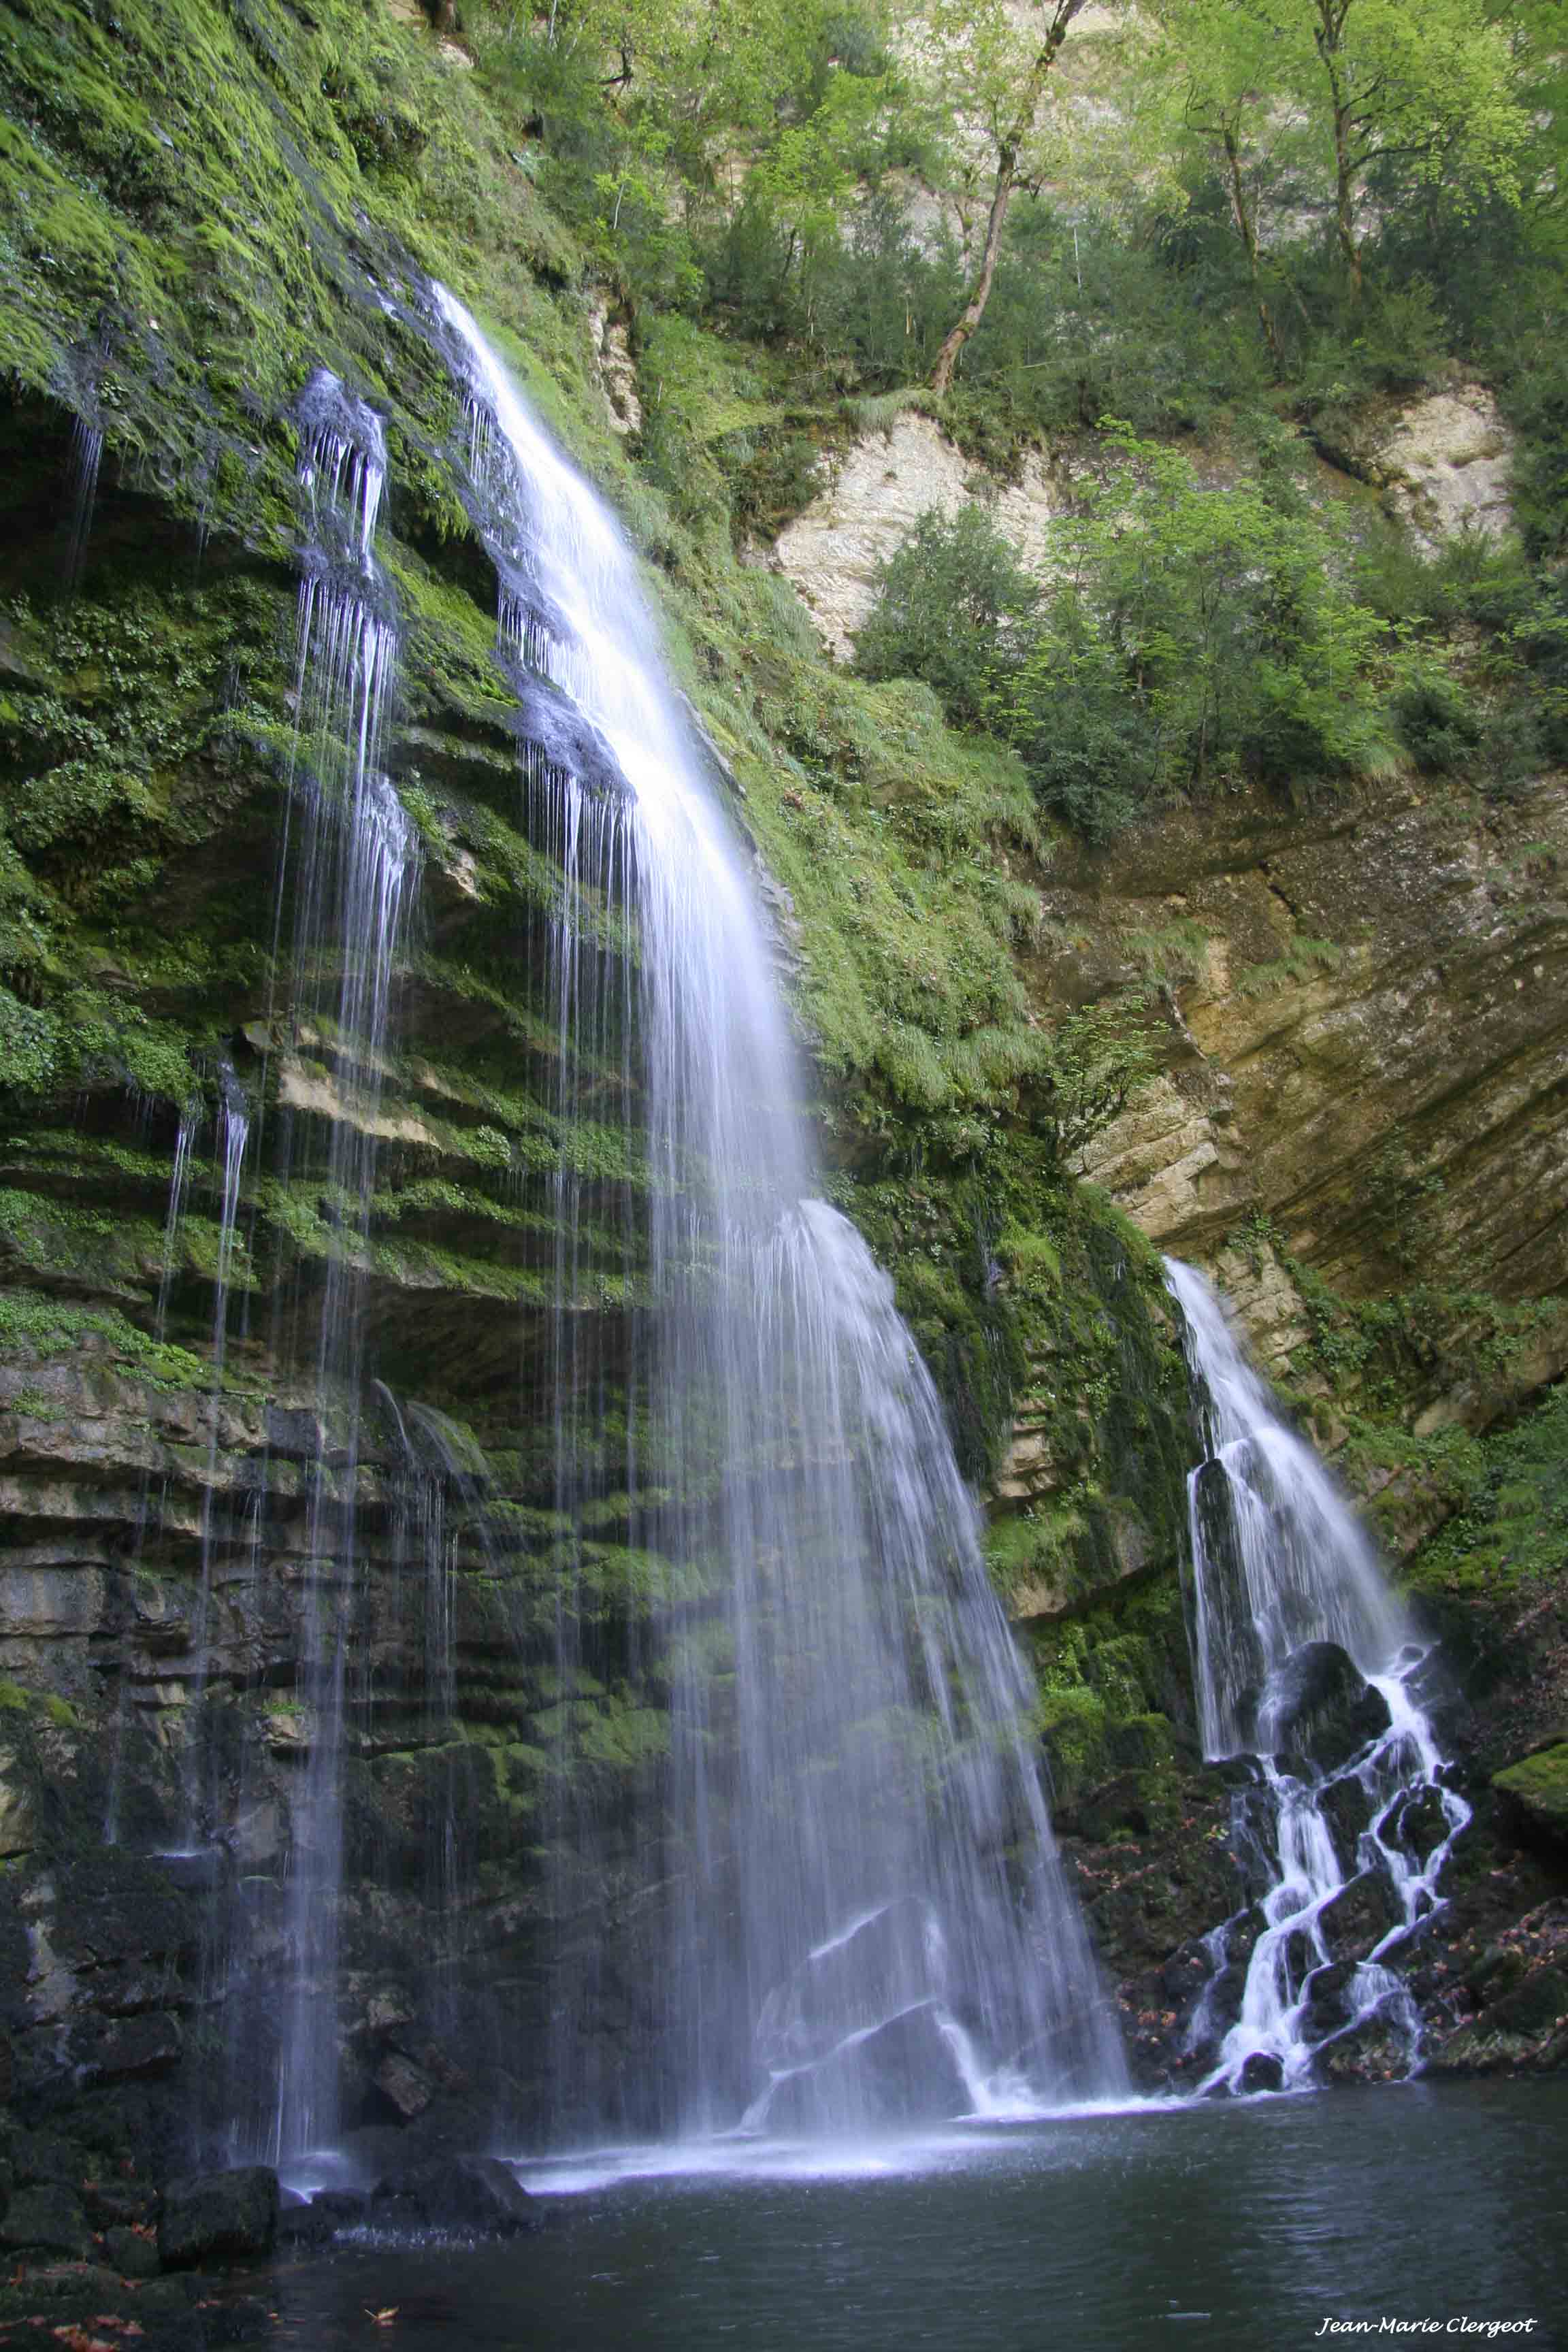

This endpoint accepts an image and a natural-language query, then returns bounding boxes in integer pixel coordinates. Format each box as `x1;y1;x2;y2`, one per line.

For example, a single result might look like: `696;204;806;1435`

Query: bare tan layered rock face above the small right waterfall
1039;776;1568;1364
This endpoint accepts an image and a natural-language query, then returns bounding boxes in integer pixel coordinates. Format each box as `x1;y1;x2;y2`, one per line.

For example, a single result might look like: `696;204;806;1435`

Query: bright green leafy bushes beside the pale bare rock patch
858;428;1408;840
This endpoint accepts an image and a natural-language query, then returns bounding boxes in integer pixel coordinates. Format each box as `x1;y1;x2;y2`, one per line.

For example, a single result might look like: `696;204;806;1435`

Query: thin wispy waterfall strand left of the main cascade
268;370;416;2157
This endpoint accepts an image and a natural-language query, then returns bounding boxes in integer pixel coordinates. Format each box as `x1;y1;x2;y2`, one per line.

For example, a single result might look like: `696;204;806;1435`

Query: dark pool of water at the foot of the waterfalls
268;2082;1568;2352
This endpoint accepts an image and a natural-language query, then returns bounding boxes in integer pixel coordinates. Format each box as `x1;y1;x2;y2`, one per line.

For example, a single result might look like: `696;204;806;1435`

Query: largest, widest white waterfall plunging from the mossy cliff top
435;289;1124;2136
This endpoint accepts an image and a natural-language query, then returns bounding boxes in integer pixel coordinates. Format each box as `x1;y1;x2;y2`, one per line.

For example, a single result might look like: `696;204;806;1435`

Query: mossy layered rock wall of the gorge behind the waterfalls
0;0;1568;2220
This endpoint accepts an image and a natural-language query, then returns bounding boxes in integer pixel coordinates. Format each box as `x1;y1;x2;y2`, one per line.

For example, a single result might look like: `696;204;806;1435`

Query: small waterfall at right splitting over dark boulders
1166;1258;1469;2091
